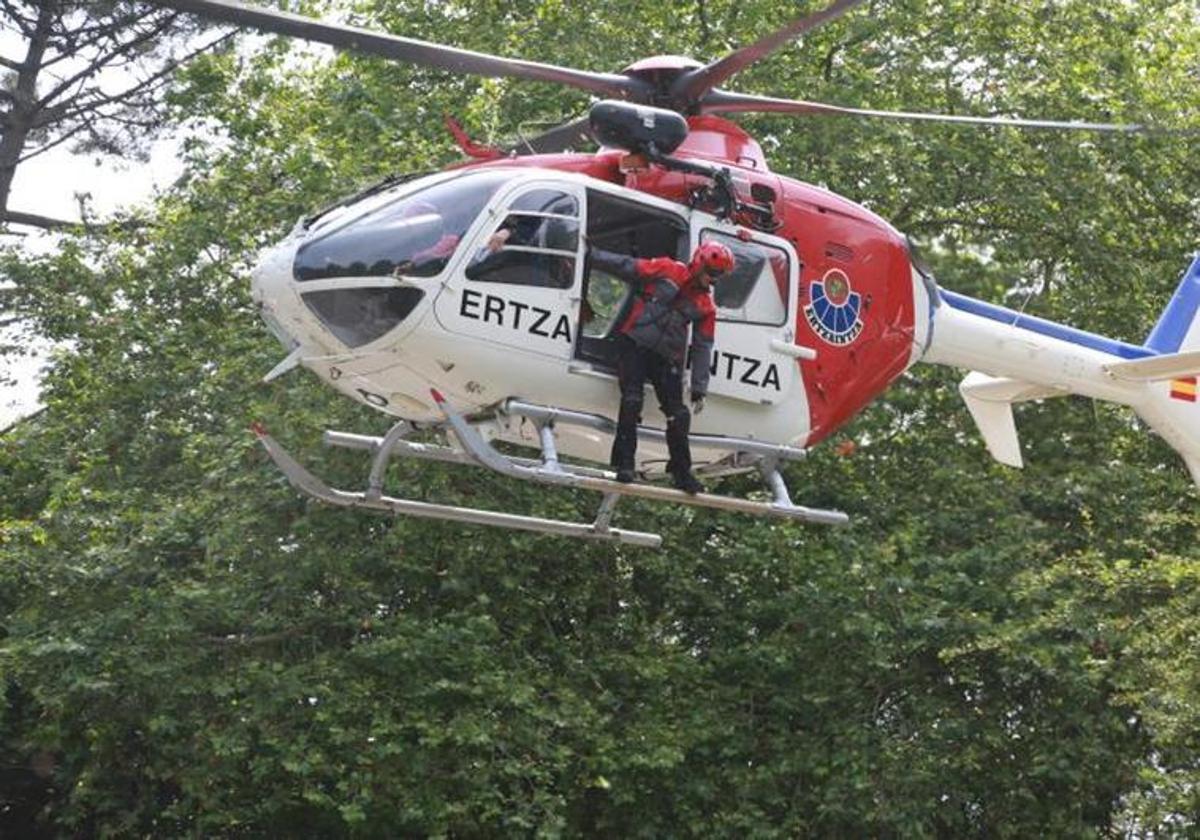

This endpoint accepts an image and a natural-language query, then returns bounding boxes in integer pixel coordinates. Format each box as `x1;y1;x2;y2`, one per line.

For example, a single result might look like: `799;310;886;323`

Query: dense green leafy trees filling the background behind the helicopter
0;0;1200;838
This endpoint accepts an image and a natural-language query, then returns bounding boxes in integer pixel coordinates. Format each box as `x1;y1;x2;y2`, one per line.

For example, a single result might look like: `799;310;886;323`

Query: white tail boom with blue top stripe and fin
922;257;1200;486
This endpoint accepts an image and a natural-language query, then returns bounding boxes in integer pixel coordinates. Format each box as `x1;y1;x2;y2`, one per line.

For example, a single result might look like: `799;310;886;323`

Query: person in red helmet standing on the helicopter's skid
590;242;733;494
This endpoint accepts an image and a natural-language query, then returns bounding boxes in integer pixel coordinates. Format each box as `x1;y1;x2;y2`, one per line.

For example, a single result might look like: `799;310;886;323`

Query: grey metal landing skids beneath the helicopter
254;392;850;548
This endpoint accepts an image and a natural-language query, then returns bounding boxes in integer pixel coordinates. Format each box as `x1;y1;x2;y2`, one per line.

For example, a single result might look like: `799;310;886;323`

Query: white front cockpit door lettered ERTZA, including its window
434;181;584;361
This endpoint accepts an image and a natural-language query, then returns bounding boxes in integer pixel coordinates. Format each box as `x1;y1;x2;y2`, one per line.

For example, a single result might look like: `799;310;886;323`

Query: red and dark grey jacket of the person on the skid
592;248;716;394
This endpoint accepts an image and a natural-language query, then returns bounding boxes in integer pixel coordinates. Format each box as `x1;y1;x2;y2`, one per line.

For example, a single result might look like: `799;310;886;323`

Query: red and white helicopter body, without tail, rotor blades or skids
253;116;936;472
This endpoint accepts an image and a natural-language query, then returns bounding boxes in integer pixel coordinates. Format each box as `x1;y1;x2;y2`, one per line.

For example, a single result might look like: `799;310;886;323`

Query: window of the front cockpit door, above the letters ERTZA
467;190;580;289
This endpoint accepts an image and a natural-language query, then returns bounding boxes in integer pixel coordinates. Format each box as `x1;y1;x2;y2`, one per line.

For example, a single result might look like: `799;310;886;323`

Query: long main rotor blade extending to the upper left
158;0;650;98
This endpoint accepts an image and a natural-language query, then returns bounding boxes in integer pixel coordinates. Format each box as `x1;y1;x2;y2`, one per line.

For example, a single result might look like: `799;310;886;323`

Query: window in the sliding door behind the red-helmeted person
701;230;790;326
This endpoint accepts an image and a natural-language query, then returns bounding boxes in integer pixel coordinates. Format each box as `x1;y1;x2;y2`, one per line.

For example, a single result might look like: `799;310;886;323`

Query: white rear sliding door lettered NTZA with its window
694;220;799;406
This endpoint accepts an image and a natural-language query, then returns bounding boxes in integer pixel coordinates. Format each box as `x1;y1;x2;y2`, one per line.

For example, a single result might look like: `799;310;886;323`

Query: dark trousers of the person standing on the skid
612;336;691;474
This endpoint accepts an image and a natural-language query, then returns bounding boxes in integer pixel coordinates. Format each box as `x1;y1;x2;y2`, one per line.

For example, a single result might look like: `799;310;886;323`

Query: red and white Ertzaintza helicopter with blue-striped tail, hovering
157;0;1200;547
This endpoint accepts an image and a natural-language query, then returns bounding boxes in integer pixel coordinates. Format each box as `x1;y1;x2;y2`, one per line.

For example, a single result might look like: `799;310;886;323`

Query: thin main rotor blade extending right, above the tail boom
700;90;1200;134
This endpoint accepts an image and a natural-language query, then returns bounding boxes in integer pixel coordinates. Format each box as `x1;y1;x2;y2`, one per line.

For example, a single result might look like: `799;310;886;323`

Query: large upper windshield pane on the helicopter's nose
293;172;512;281
